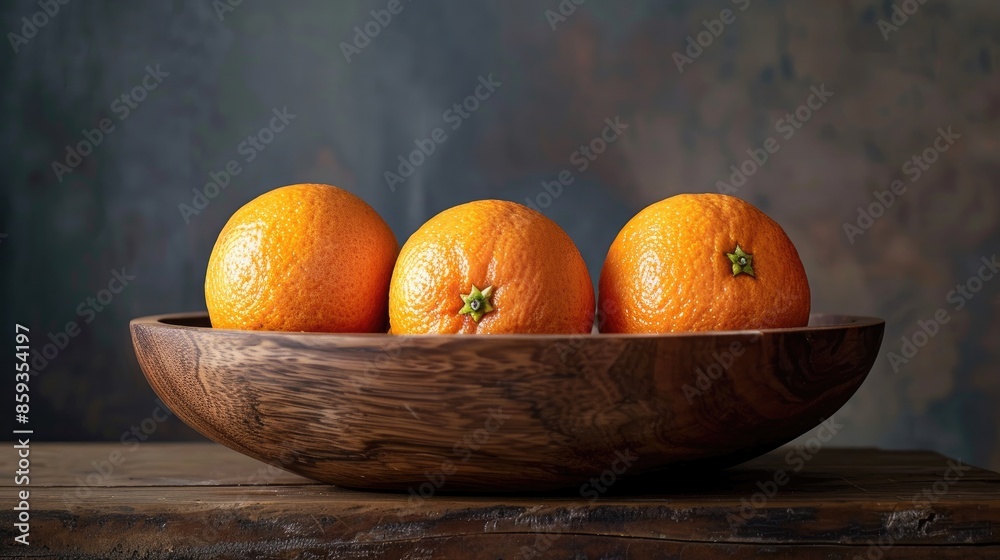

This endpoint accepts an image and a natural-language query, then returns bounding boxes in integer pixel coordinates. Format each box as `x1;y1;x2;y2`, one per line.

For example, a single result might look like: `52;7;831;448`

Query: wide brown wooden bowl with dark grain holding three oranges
131;314;885;496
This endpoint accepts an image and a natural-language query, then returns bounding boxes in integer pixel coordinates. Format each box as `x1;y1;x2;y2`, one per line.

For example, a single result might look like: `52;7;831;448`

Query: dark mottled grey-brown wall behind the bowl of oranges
0;0;1000;468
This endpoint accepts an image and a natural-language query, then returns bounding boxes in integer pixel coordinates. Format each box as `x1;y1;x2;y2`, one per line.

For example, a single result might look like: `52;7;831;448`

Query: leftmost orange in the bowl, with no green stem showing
205;184;399;332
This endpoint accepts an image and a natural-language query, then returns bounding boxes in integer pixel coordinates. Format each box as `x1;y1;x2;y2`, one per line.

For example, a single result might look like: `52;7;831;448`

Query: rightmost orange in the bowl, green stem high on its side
599;194;809;333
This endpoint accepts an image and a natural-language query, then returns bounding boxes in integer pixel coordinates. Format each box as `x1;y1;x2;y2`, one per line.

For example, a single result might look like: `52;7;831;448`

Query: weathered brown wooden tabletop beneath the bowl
7;442;1000;560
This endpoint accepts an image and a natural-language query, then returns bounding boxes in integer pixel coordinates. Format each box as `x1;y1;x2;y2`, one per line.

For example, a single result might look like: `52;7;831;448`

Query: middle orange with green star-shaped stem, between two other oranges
389;200;594;334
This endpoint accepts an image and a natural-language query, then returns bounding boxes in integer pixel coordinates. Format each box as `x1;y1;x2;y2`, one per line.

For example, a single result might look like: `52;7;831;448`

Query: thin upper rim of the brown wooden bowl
129;311;885;341
